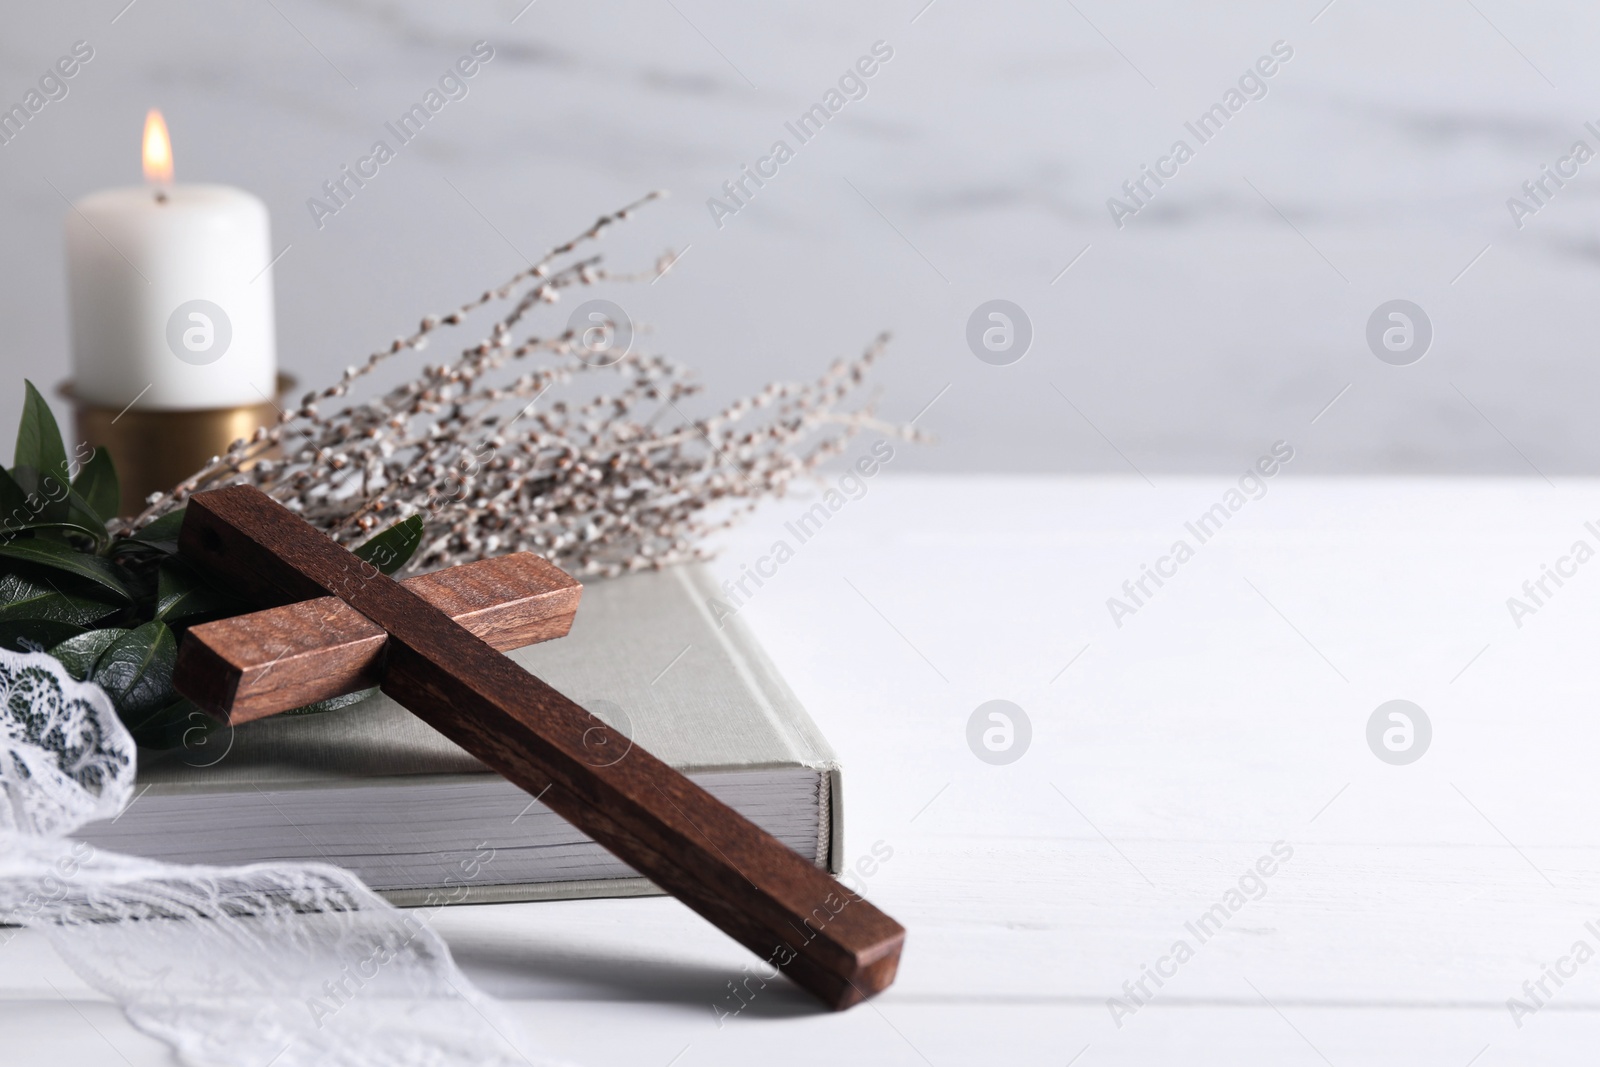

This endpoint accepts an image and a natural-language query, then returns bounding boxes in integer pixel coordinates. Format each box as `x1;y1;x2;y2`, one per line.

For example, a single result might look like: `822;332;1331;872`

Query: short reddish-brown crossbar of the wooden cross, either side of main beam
176;552;582;725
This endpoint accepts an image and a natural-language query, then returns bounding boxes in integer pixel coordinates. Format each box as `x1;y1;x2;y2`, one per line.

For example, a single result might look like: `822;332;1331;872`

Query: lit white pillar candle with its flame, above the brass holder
67;110;277;411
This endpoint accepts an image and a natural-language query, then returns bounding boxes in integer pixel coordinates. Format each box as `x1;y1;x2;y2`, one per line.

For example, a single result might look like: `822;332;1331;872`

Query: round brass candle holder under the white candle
61;374;294;515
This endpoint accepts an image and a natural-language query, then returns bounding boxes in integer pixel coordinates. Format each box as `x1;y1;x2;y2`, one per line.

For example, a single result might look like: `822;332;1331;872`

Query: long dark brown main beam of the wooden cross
179;486;906;1009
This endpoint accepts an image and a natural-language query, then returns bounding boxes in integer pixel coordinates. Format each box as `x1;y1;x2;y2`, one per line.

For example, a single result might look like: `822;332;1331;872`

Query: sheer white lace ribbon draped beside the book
0;649;556;1067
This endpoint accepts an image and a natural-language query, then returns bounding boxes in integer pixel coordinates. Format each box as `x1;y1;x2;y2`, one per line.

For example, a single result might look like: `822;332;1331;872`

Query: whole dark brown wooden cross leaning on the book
174;486;906;1009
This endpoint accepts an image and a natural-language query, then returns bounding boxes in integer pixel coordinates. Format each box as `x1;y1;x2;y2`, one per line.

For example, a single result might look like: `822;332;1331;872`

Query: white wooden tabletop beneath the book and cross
0;479;1600;1067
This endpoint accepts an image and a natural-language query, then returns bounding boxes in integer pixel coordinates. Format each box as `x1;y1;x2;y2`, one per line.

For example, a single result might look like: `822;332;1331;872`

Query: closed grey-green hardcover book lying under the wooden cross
78;566;842;904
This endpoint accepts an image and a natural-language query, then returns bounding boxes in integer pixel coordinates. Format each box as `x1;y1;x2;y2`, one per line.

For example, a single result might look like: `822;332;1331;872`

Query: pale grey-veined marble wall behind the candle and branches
0;0;1600;477
